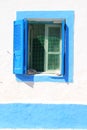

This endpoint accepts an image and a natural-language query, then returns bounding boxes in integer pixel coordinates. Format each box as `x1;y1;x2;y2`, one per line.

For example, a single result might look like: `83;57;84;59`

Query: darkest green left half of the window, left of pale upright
31;24;45;72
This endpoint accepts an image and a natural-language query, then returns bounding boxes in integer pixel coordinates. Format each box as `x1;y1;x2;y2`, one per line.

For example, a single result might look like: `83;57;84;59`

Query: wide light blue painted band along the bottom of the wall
0;104;87;129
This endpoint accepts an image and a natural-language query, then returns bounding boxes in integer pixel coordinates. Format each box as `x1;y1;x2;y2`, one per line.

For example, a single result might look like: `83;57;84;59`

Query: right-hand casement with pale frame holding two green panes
45;24;62;74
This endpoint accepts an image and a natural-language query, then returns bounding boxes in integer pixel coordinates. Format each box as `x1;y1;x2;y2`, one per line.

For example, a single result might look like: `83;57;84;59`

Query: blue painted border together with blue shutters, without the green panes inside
13;11;74;82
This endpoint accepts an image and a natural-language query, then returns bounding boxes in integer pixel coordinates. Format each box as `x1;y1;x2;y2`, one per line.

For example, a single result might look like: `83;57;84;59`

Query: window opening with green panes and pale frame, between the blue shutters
28;23;62;73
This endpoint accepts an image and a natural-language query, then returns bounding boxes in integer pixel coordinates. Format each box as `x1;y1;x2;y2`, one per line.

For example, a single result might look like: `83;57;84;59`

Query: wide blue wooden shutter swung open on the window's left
13;20;25;74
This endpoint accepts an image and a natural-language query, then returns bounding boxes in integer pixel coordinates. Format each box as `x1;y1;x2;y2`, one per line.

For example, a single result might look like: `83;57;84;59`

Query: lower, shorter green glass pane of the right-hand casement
48;54;60;70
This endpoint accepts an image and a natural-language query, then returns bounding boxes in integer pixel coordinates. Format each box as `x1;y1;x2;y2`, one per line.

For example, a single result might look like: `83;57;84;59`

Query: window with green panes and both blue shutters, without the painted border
14;19;65;75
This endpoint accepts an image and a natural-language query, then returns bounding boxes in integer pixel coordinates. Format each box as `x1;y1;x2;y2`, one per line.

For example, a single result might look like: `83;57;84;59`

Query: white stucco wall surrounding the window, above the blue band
0;0;87;104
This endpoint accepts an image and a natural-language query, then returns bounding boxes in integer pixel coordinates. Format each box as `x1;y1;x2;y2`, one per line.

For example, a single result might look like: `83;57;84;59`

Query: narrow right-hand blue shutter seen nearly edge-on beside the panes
61;20;65;75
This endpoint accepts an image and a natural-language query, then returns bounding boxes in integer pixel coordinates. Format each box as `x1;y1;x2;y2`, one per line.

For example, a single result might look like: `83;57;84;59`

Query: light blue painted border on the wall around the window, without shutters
16;11;74;82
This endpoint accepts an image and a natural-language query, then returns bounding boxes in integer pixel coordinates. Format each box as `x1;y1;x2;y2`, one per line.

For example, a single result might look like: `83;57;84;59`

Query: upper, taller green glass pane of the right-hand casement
48;27;60;52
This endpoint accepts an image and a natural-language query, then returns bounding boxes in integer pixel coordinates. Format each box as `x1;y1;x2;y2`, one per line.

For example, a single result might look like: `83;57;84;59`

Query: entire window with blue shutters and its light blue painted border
13;11;73;81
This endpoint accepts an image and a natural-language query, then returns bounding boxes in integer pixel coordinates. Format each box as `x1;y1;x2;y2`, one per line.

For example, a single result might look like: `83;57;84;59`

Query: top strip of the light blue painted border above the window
16;11;74;20
